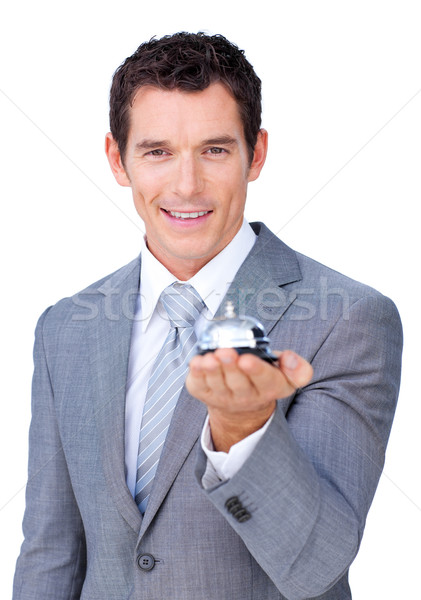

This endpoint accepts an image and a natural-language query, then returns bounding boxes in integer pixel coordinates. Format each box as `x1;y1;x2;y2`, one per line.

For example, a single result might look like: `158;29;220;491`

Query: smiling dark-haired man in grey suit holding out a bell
14;33;402;600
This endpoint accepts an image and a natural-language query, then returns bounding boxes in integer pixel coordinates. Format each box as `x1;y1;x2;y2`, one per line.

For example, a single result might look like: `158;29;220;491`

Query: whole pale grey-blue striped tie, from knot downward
135;282;204;514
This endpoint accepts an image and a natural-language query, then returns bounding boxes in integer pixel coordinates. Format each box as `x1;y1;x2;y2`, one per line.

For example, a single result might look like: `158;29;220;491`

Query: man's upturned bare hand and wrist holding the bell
186;348;313;452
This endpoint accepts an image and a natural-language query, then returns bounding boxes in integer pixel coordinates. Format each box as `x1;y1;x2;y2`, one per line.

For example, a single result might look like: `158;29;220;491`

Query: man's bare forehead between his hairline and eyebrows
129;83;243;141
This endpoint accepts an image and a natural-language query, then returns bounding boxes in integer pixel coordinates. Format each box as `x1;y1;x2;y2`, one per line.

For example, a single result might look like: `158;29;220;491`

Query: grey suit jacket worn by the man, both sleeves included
14;224;402;600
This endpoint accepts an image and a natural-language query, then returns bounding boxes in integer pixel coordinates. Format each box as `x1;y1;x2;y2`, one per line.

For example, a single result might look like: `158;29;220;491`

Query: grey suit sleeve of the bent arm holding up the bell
197;295;402;600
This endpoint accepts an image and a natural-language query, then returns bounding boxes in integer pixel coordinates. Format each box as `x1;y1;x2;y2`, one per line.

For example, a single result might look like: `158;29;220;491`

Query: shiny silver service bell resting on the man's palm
197;301;278;363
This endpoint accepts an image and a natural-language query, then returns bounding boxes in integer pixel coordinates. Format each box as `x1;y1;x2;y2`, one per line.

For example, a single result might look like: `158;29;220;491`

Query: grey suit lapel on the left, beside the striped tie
89;259;141;532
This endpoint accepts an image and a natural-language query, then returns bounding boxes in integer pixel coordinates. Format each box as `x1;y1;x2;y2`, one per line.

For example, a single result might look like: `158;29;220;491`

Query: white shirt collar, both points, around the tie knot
140;219;257;331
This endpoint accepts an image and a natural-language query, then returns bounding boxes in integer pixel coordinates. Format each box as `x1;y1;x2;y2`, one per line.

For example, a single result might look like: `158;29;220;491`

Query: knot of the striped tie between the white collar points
161;282;205;327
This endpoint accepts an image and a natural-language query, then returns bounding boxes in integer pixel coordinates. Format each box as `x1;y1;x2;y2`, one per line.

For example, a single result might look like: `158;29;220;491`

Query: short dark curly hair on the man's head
110;32;262;163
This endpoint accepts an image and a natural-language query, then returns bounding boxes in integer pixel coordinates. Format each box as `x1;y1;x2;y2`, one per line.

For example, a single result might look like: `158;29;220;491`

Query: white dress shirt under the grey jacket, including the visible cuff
125;221;267;497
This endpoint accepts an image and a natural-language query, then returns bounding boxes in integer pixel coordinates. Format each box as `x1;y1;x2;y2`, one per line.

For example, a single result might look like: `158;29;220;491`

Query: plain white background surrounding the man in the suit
0;0;421;600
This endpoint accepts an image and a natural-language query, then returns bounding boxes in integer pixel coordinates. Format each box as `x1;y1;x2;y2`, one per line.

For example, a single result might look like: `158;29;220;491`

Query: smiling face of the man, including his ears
106;83;267;280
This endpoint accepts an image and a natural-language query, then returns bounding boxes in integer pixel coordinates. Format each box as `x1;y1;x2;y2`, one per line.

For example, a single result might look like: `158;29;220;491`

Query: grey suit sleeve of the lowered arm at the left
13;311;86;600
